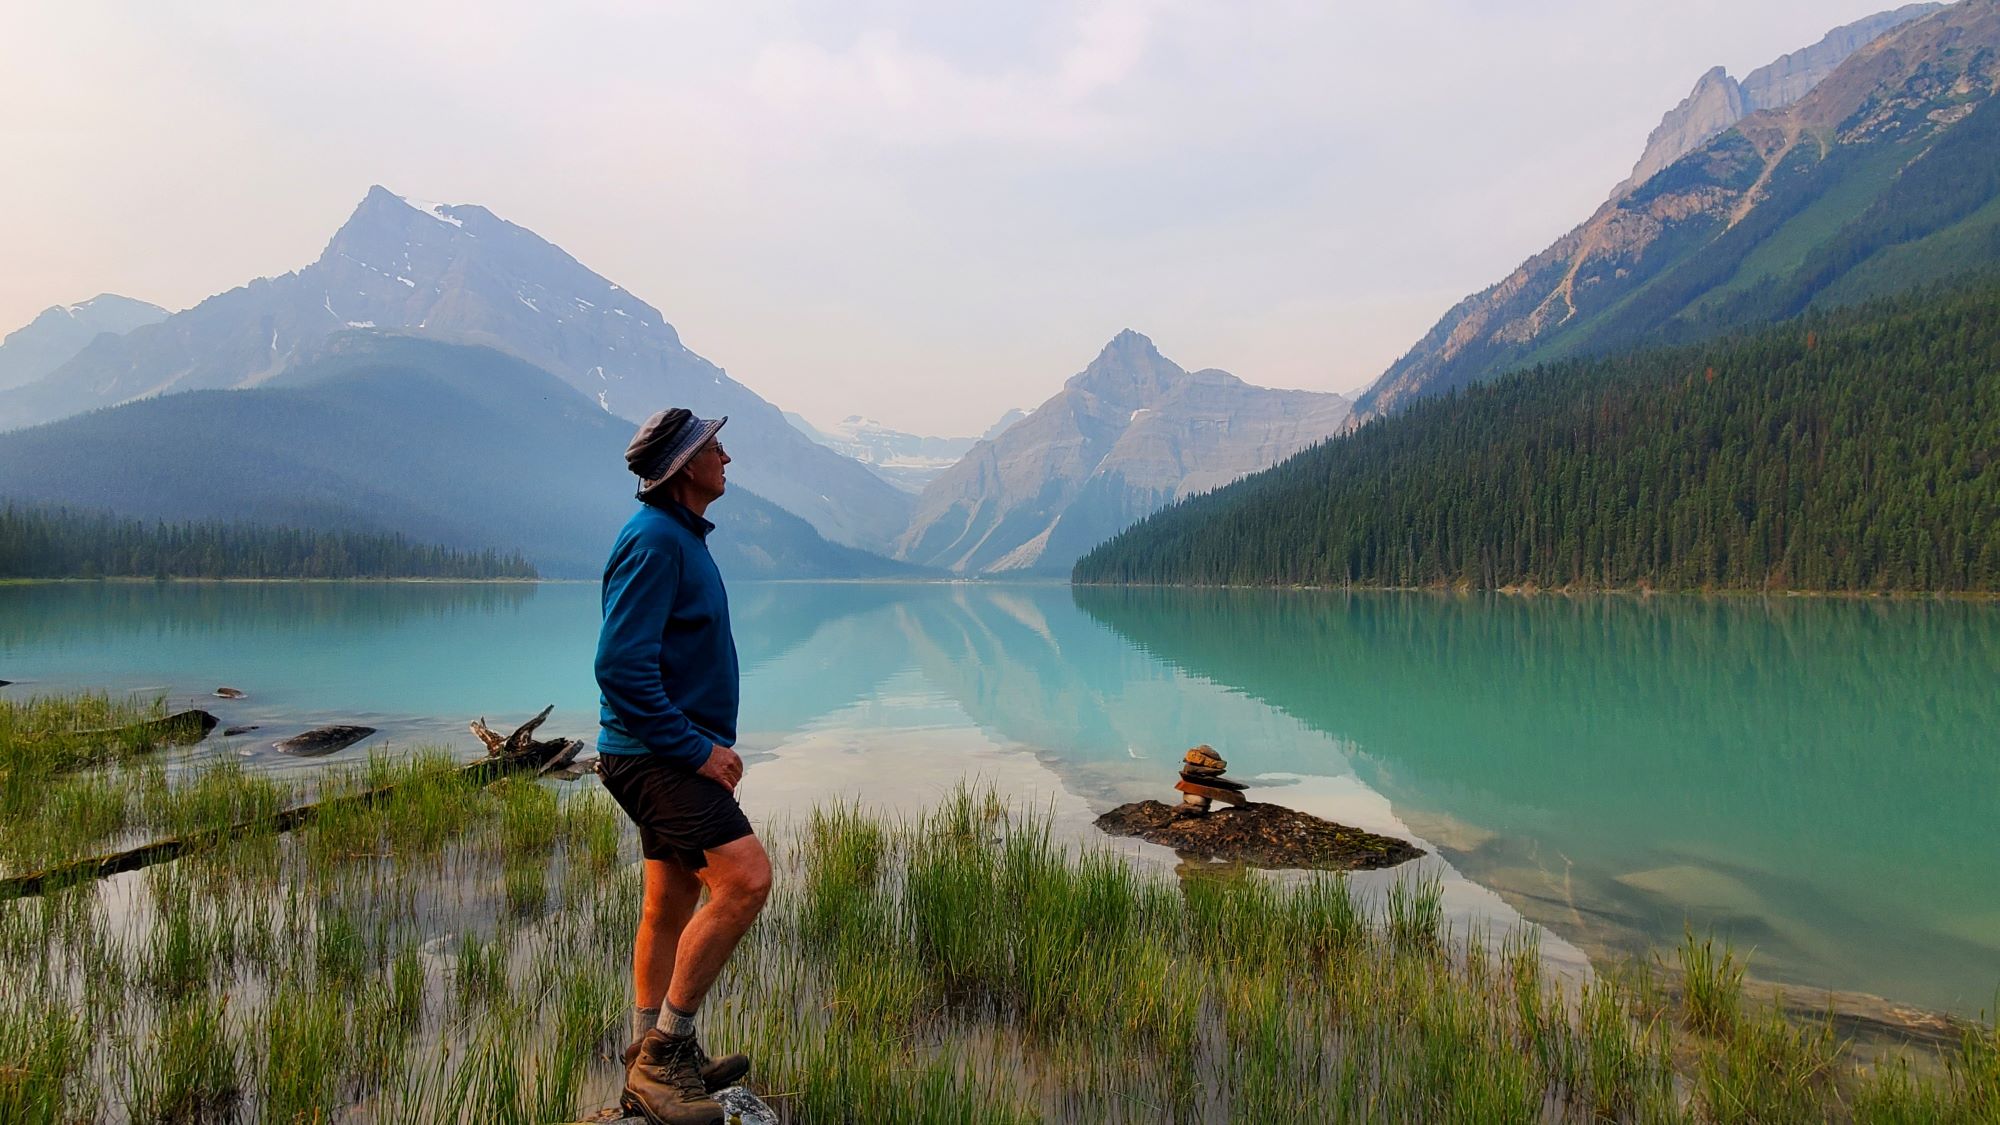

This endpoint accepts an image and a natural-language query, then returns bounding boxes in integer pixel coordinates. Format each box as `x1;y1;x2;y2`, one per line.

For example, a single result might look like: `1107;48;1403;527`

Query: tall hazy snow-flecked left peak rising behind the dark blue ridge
0;186;910;546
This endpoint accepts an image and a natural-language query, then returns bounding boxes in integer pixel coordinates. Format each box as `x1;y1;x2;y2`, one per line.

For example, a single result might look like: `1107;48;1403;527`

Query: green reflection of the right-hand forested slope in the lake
1076;589;2000;1013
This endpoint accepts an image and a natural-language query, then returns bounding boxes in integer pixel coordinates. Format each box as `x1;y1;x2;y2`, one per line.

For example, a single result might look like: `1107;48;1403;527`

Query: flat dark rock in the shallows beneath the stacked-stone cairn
1096;801;1424;871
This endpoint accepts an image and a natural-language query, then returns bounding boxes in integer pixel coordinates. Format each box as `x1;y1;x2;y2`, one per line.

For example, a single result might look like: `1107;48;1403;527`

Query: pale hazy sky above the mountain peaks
0;0;1890;434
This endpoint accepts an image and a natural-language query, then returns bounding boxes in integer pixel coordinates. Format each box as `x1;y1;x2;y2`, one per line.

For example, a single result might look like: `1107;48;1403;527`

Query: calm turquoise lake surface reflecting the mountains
0;583;2000;1015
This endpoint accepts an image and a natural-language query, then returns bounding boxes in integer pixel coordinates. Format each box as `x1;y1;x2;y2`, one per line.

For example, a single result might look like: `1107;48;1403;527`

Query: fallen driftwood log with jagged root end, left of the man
0;705;584;901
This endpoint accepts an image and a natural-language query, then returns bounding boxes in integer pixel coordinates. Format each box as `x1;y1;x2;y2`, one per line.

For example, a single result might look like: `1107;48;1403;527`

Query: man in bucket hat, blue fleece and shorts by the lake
596;408;770;1125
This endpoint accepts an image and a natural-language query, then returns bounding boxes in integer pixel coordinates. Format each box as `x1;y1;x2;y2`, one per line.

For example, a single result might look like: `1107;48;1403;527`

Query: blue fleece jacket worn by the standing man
598;500;738;771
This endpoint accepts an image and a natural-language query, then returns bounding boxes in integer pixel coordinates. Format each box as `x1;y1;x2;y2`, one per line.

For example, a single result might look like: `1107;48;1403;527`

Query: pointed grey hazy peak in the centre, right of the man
898;330;1348;575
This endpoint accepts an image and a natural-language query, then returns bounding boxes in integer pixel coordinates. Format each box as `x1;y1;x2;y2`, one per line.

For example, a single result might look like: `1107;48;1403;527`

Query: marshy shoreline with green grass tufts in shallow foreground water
0;697;2000;1123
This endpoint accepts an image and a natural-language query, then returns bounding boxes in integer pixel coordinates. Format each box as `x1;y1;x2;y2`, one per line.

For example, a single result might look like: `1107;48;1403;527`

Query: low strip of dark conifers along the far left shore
0;504;536;579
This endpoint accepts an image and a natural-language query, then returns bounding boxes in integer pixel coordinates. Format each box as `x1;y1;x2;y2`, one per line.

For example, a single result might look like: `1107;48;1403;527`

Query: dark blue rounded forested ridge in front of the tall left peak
0;330;908;579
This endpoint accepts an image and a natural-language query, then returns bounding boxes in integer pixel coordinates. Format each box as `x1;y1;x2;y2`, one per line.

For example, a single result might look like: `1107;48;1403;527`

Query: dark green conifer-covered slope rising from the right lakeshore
1074;282;2000;593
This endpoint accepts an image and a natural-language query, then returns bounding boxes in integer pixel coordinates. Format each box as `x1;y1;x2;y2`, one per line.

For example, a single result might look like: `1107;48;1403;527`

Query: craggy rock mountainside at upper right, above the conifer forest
1356;0;2000;416
